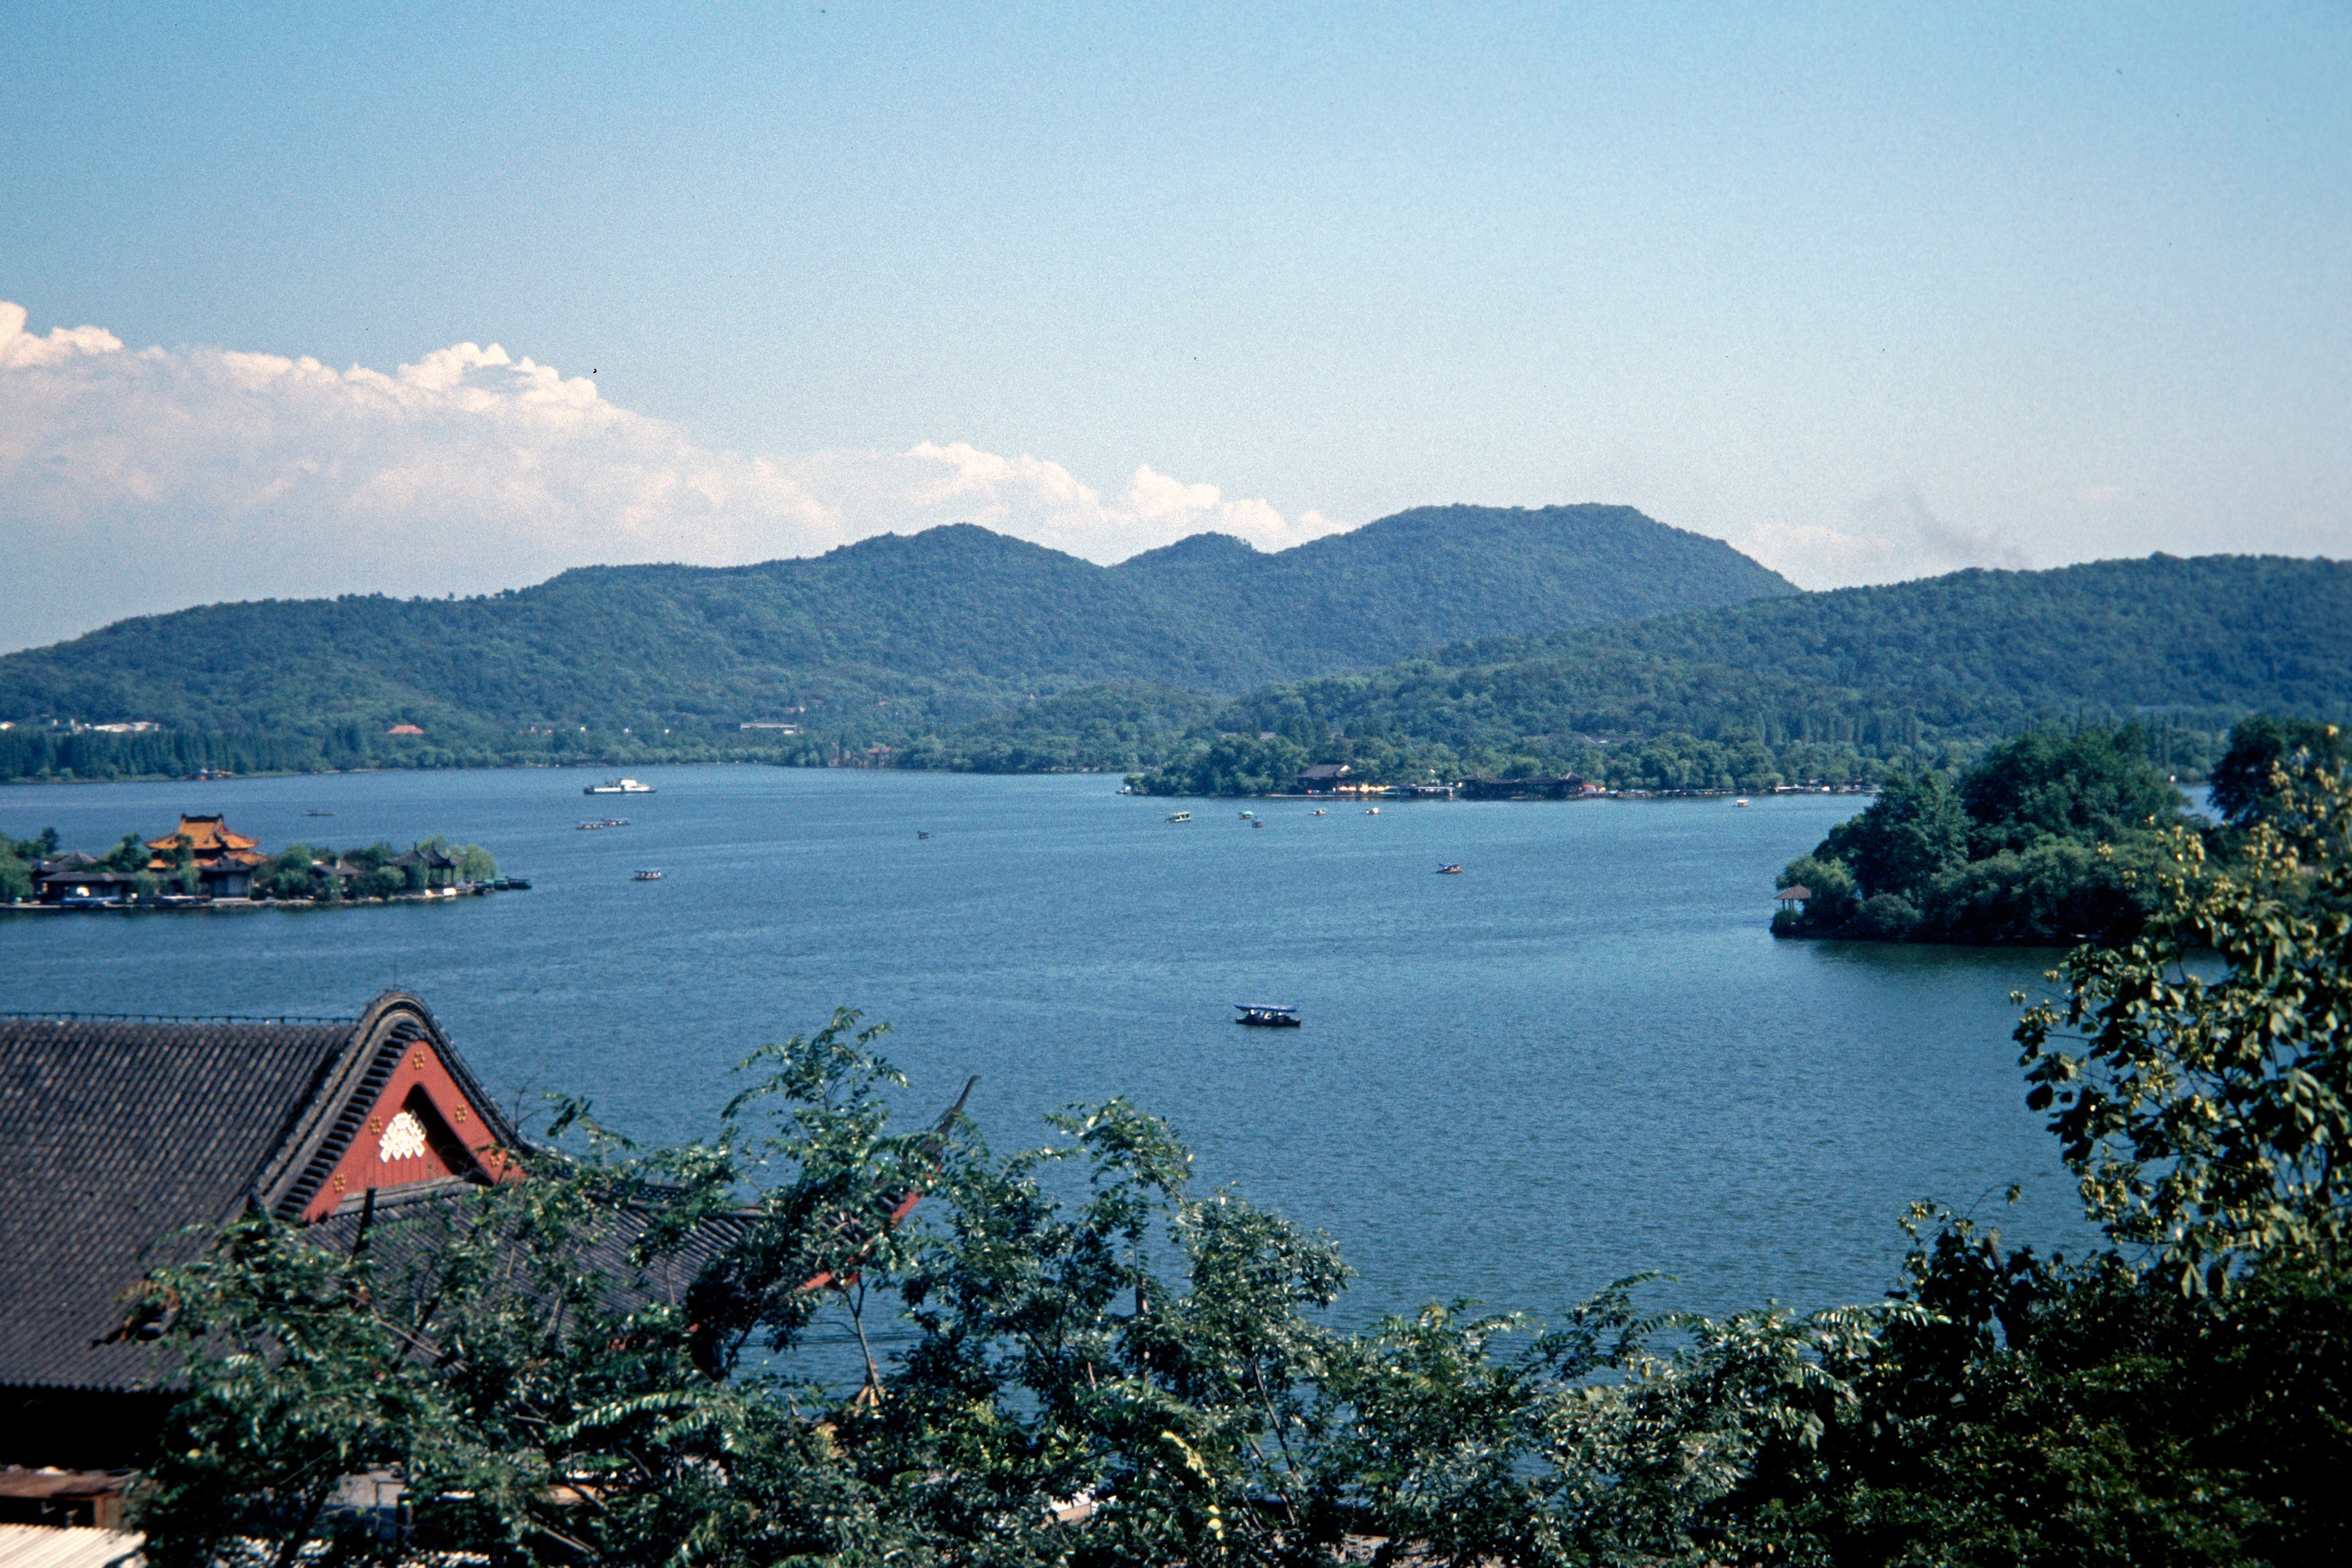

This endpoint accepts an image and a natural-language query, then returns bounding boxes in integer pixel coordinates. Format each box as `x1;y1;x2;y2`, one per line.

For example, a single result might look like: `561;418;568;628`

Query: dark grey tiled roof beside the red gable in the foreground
0;992;512;1389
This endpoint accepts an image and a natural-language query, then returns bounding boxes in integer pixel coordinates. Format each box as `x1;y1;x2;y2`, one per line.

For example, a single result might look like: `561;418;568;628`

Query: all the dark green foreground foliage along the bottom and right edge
141;759;2352;1568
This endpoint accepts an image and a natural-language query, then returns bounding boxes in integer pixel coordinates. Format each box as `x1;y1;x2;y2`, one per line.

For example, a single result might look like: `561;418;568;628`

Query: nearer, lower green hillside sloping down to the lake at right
1124;554;2352;787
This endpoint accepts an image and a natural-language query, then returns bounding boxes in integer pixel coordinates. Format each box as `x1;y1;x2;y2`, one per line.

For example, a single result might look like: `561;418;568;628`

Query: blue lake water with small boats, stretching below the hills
0;766;2084;1316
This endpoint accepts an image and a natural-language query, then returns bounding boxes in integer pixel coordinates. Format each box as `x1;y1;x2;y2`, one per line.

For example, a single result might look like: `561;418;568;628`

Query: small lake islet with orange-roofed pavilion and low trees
12;813;510;910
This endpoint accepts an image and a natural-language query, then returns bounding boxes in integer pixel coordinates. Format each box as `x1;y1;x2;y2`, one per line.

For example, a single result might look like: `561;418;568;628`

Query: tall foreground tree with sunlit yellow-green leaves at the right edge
2018;759;2352;1293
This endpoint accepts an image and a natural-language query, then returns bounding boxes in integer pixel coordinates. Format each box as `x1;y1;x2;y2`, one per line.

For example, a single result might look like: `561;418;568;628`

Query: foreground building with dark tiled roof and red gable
0;992;520;1467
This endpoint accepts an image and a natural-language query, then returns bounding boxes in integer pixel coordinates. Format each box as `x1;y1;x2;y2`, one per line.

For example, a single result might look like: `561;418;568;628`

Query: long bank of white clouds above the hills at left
0;303;1341;649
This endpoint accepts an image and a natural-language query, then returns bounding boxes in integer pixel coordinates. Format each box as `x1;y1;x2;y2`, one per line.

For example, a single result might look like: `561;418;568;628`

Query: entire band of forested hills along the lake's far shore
0;545;2352;794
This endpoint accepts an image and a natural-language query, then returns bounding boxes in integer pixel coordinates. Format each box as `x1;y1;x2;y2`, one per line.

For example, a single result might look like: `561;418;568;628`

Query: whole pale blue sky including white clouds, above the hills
0;0;2352;646
